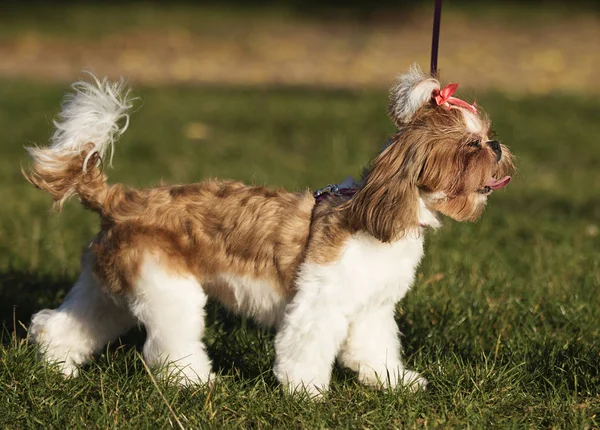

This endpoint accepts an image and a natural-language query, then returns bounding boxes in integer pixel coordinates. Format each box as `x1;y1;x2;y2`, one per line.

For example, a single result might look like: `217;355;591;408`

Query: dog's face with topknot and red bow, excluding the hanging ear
388;67;513;221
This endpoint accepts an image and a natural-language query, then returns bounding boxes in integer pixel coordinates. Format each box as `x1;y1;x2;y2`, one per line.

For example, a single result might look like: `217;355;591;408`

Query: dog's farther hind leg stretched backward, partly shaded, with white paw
29;256;135;376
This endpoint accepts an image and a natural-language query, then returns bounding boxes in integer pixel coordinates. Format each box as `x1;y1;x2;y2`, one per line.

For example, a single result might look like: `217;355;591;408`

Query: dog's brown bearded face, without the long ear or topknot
404;106;513;221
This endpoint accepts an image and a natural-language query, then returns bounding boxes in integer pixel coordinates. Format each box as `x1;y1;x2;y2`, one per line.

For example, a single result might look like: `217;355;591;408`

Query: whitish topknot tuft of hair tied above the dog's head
388;64;440;129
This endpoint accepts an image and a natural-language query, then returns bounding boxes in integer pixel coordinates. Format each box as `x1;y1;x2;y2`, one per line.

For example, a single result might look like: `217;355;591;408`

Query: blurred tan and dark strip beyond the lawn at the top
0;0;600;94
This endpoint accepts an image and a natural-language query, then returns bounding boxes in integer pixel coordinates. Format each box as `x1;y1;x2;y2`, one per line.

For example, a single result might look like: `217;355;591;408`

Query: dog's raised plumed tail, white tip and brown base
23;75;132;215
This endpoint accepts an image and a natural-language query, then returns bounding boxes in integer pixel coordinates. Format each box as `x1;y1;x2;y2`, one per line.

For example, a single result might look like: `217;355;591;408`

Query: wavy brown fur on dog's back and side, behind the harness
93;181;314;294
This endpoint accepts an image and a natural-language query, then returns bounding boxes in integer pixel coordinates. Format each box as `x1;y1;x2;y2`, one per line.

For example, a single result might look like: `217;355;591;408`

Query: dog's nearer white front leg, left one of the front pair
274;284;348;397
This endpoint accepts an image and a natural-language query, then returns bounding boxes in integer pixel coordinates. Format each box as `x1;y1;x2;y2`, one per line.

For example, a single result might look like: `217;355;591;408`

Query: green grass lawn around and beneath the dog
0;81;600;428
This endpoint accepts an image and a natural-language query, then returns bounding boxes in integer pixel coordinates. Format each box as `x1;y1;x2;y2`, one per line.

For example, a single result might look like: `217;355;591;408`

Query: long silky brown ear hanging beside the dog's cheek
340;135;424;242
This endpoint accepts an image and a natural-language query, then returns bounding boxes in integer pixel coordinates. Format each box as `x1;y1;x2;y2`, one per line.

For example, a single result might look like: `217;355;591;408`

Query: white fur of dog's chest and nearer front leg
274;233;423;395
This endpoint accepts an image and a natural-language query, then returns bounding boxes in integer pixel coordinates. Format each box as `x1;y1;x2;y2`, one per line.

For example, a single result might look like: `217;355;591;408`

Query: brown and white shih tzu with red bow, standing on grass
24;67;513;396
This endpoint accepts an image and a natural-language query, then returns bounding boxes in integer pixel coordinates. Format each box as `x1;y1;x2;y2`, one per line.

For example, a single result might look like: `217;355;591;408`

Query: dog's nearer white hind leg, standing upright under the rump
130;254;213;385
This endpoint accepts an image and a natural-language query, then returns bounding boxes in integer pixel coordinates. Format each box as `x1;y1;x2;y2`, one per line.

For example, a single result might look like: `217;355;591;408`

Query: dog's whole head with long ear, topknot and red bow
347;67;513;242
